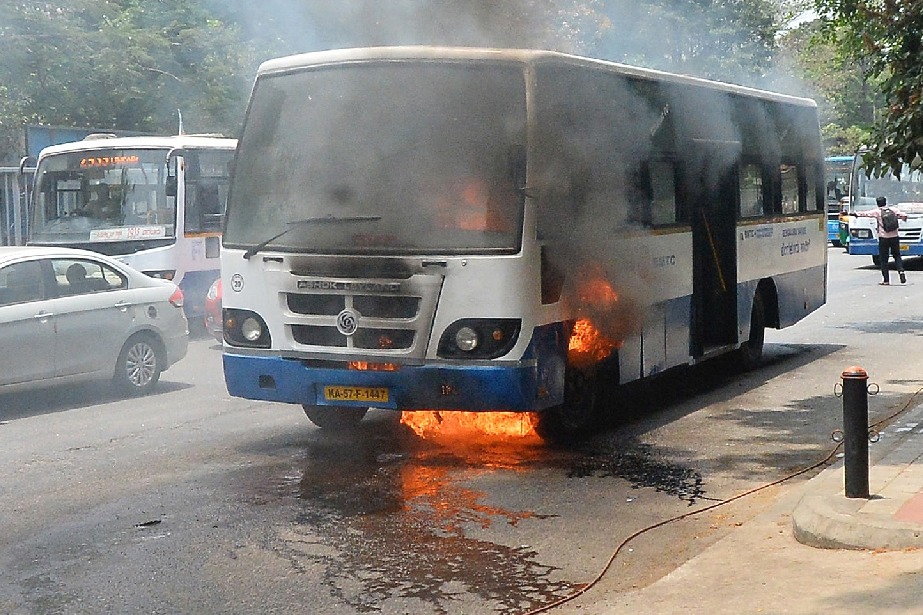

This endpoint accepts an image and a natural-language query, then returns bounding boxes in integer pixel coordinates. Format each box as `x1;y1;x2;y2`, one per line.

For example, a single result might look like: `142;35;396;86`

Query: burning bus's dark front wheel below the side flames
535;368;599;442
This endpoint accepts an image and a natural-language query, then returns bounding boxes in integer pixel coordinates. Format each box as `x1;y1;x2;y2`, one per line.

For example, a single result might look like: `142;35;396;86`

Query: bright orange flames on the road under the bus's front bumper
401;410;538;439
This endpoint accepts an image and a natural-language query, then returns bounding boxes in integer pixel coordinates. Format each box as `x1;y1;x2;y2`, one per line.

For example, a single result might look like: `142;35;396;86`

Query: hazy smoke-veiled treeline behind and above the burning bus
0;0;884;164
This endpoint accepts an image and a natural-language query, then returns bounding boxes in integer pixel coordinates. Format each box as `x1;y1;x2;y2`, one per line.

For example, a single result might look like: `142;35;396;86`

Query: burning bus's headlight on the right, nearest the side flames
437;318;522;359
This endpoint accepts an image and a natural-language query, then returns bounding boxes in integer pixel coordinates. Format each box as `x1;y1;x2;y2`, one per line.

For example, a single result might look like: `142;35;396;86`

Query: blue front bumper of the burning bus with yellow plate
223;352;563;412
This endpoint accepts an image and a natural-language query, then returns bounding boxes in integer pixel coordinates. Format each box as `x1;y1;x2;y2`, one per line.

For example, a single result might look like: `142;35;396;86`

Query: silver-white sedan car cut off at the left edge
0;246;189;395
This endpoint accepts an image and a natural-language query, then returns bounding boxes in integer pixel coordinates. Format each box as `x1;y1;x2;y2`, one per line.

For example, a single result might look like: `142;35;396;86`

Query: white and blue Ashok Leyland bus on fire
221;47;827;437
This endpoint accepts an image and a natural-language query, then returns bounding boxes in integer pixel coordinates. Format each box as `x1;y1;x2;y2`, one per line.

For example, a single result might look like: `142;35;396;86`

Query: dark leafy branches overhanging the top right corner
817;0;923;172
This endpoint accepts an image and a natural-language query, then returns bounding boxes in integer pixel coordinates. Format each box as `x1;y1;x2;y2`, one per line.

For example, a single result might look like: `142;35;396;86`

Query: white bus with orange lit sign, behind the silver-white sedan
28;135;237;318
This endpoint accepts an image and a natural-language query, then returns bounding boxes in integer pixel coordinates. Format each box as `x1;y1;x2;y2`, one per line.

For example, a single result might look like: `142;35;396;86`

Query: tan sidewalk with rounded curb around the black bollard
553;405;923;615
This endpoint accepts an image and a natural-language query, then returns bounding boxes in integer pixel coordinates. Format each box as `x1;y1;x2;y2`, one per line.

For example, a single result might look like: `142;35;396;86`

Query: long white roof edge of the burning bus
257;46;817;107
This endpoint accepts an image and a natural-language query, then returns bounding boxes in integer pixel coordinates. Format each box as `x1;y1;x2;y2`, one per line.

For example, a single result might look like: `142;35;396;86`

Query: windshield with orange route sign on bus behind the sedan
31;149;176;245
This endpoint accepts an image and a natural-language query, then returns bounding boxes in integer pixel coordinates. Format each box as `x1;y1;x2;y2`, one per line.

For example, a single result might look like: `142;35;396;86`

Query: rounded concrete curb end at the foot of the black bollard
792;495;923;551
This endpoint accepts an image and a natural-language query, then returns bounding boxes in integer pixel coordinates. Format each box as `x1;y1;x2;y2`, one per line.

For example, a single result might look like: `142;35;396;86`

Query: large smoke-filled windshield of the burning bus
224;61;526;254
